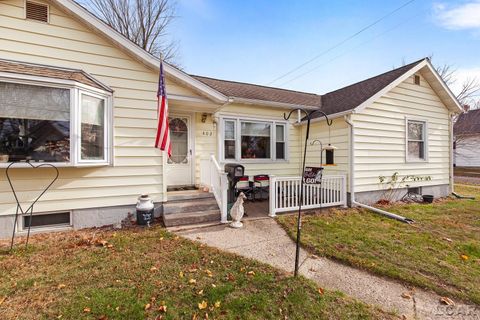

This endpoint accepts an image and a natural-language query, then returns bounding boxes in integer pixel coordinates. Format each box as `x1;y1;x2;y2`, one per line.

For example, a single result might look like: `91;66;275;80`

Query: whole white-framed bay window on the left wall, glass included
0;79;111;166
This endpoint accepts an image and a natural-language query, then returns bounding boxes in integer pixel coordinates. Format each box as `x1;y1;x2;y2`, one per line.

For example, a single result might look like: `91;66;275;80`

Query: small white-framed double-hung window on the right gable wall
406;119;427;161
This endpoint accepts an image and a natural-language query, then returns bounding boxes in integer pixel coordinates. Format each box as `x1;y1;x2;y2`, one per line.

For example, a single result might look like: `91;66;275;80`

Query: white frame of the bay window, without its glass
0;72;113;168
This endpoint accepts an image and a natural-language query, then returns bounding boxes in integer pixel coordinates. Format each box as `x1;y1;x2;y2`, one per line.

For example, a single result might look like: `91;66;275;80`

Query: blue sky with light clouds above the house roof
165;0;480;94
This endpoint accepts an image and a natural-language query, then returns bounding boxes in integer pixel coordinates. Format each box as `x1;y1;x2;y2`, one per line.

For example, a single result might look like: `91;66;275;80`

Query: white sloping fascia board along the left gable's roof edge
54;0;227;102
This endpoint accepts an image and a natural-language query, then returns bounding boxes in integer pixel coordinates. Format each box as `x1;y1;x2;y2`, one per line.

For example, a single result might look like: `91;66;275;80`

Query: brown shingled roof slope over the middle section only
192;76;321;108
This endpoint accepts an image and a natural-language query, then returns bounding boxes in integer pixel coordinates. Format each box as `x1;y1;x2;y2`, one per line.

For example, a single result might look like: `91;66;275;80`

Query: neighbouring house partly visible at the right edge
453;109;480;167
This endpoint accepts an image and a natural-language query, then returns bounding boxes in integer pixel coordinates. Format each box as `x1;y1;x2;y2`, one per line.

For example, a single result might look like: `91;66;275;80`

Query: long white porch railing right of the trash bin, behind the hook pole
269;175;347;217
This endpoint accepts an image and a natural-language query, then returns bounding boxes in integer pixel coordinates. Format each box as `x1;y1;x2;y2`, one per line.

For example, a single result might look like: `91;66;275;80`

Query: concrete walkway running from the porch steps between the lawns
173;218;480;320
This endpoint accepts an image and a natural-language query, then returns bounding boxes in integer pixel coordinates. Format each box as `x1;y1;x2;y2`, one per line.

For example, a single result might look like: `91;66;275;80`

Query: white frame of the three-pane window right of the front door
218;116;289;163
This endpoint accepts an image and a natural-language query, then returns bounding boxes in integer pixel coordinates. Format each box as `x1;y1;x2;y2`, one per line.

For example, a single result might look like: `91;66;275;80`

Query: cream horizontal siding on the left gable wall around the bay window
0;0;206;215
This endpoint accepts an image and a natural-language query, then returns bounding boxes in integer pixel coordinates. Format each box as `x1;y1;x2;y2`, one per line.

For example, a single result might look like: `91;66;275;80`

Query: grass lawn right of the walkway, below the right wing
279;186;480;304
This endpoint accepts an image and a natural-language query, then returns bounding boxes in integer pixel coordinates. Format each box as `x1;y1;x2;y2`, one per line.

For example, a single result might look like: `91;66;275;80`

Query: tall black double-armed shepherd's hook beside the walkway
283;108;332;277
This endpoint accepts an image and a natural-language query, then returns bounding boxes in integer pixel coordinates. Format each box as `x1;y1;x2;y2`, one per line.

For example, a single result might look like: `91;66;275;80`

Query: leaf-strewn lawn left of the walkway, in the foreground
0;227;393;320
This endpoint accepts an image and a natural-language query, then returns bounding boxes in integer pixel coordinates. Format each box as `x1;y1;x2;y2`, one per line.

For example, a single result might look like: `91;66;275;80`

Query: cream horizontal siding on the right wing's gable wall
352;76;451;192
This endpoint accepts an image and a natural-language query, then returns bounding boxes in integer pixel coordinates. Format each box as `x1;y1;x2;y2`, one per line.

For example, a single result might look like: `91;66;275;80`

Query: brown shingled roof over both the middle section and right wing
192;59;425;114
